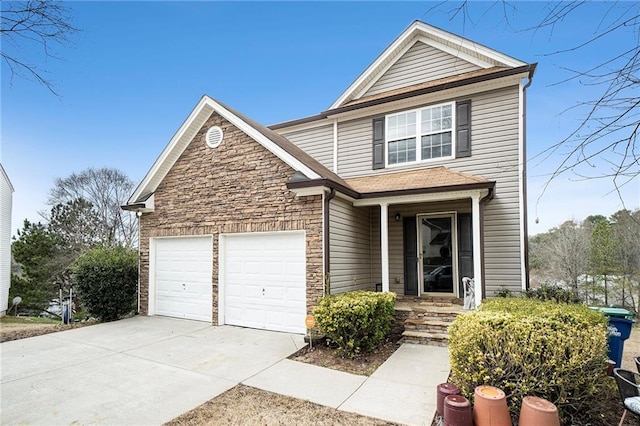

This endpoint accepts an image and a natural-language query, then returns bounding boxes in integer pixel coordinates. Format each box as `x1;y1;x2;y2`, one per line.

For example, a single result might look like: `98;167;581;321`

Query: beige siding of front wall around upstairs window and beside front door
338;86;522;296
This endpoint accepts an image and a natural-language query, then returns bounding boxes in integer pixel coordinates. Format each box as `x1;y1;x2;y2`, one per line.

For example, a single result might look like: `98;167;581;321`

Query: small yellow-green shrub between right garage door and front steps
313;291;396;358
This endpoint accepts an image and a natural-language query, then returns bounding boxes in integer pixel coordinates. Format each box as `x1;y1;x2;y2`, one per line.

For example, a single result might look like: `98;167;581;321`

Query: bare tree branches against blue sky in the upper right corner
429;0;640;204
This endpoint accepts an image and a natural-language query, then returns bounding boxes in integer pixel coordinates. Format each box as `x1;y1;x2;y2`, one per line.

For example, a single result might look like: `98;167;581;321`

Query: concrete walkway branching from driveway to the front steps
243;343;449;425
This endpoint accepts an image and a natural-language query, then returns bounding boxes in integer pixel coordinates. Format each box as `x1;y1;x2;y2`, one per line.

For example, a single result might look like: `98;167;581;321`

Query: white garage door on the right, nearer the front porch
222;232;306;333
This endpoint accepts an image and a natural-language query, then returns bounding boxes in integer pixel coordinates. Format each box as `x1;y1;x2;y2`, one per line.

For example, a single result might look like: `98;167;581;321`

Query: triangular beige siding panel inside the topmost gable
363;41;480;96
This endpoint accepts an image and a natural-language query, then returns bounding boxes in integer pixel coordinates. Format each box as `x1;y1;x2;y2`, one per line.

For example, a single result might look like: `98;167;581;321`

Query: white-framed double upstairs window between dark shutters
386;103;454;166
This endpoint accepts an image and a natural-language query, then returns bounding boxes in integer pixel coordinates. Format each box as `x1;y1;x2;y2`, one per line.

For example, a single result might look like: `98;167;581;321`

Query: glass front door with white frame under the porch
417;213;458;295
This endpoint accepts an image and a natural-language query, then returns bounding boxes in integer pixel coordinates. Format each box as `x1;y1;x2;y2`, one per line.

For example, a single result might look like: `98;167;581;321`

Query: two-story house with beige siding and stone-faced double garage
124;21;535;332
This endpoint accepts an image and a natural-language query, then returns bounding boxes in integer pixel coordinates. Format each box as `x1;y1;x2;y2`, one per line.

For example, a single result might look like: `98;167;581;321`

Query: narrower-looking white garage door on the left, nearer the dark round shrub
155;237;213;322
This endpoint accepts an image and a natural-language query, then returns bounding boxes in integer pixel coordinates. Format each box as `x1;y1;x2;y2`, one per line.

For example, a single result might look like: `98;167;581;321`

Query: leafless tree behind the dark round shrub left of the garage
47;167;138;248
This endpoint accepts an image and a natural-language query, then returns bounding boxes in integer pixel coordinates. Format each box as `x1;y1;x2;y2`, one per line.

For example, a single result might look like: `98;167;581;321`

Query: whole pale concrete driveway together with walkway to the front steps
0;317;449;425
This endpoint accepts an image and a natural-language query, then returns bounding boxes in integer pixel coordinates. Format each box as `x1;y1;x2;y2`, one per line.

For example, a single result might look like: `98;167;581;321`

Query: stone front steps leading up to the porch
394;297;464;347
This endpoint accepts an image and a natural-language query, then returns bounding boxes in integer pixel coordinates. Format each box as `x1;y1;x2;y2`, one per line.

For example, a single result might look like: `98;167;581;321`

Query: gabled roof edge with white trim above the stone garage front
127;95;344;208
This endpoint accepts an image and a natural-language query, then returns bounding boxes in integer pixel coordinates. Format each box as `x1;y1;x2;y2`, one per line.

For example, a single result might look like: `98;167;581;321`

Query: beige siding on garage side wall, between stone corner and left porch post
329;197;375;294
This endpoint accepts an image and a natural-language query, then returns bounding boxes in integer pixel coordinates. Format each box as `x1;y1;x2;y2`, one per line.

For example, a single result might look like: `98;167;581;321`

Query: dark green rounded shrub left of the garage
73;247;138;321
